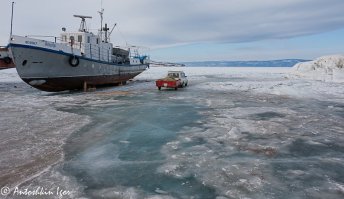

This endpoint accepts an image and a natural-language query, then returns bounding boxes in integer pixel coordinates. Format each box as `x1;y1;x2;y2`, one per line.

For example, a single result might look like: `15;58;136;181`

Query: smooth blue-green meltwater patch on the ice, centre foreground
63;91;215;198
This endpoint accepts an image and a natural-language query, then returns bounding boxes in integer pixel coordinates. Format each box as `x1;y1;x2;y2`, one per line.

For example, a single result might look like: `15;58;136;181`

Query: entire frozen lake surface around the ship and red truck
0;67;344;199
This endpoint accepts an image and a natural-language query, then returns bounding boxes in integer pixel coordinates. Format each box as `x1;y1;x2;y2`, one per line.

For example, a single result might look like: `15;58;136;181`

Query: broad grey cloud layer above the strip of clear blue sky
0;0;344;47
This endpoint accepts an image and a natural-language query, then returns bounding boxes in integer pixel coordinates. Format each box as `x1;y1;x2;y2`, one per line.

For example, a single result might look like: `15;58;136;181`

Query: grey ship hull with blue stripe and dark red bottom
10;44;148;92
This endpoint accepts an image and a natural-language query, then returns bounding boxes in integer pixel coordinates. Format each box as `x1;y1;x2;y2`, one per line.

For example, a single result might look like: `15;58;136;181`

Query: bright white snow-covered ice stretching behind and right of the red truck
137;66;344;102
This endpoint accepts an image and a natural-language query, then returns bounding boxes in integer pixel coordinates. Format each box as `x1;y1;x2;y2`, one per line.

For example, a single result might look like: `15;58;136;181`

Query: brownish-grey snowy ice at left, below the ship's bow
0;75;89;190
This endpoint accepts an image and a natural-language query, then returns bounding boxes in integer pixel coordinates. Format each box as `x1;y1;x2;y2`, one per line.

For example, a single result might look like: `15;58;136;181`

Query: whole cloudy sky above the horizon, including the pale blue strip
0;0;344;62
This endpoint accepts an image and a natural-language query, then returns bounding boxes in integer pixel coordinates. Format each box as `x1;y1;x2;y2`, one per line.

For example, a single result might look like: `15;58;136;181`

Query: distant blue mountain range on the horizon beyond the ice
179;59;310;67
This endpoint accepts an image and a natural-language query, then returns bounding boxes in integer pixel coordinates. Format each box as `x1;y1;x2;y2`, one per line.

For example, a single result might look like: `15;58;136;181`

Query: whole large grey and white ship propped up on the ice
9;12;149;92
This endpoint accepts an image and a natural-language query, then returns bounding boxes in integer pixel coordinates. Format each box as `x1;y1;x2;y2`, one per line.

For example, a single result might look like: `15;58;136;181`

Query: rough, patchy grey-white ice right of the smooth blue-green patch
158;92;344;198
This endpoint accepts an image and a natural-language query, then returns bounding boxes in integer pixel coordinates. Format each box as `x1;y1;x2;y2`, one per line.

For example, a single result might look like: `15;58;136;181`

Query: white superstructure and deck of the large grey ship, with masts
11;15;149;64
